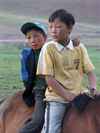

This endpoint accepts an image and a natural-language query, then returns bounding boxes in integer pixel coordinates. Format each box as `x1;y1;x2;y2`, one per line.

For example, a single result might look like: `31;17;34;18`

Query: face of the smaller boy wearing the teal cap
26;30;47;50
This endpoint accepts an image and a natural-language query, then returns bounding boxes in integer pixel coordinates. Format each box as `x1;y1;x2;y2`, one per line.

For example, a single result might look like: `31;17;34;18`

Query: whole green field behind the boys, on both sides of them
0;44;100;100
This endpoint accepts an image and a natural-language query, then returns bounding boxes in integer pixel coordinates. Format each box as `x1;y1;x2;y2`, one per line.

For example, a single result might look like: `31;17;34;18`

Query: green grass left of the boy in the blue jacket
0;47;23;100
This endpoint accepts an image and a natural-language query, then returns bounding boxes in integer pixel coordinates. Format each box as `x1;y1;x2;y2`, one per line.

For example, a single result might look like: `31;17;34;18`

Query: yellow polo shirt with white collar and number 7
37;40;94;101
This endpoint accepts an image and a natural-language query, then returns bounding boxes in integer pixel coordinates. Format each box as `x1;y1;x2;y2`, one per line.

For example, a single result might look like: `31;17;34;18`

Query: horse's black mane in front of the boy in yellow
69;94;100;112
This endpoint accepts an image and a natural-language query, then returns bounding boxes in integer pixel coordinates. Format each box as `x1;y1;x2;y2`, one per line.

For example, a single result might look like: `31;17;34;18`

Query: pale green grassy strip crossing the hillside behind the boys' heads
0;11;100;33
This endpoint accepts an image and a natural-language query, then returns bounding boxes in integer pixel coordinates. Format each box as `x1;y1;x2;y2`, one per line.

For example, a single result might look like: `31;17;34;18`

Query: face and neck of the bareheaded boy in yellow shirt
49;18;73;46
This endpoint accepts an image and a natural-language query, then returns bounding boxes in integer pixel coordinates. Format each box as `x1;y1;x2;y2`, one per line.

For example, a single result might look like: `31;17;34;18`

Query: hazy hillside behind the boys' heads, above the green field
0;0;100;44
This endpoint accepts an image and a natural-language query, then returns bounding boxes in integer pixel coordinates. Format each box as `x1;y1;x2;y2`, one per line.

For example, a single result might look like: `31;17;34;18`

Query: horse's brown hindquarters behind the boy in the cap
0;90;34;133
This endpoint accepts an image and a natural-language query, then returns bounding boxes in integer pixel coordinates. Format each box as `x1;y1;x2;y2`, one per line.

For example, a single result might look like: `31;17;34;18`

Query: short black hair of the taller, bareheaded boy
49;9;75;27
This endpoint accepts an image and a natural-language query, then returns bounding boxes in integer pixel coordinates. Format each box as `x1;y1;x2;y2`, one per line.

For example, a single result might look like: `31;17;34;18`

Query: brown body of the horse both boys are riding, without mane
0;90;100;133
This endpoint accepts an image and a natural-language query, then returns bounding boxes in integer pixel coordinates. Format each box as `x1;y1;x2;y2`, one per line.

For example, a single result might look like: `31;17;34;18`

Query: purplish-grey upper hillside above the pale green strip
0;0;100;25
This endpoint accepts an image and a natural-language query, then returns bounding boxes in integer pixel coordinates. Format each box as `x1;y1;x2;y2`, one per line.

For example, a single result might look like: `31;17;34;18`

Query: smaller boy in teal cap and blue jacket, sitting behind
19;22;47;133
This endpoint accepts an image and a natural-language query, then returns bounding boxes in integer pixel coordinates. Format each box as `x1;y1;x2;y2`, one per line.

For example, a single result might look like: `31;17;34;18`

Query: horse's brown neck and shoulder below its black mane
62;98;100;133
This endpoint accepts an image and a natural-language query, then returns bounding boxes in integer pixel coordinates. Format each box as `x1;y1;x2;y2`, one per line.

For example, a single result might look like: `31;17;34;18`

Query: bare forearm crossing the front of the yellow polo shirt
45;75;74;101
